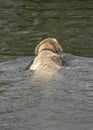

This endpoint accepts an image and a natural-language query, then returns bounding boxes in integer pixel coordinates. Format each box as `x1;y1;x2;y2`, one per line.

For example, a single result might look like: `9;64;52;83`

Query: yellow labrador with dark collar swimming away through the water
29;38;62;74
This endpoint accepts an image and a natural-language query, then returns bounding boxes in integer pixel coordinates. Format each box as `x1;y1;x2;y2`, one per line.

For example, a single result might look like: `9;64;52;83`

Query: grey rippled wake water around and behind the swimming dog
0;54;93;130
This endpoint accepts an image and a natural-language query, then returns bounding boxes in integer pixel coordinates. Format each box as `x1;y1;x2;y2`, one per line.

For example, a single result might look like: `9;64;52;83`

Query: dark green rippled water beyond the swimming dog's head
0;0;93;61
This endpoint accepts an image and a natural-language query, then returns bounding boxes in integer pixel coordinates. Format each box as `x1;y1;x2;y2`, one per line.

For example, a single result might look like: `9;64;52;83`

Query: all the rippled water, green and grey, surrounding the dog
0;0;93;130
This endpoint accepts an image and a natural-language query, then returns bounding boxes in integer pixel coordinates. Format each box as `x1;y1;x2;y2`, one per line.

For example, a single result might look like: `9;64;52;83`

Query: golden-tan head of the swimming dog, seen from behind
35;38;62;55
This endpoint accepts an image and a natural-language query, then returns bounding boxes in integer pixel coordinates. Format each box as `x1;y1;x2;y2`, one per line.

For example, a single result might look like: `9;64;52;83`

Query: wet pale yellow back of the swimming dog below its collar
30;51;62;70
